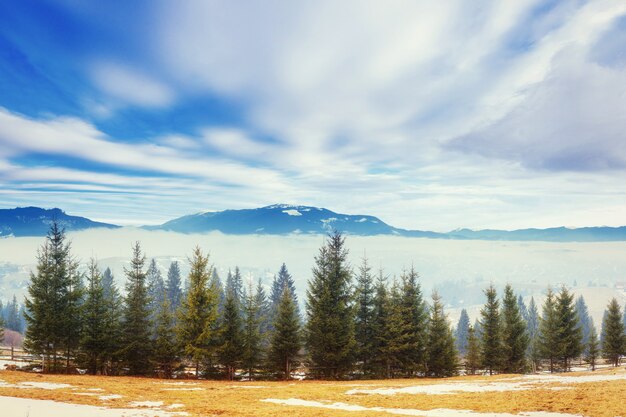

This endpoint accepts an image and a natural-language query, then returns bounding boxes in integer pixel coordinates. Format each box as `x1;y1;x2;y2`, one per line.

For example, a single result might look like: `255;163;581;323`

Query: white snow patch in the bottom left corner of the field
0;396;187;417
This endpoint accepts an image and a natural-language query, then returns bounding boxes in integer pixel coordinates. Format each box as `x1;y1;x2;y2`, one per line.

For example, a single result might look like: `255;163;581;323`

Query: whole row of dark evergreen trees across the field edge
14;224;626;379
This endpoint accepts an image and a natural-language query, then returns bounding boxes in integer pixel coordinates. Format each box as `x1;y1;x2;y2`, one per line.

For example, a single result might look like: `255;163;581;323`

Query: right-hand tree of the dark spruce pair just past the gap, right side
501;284;528;373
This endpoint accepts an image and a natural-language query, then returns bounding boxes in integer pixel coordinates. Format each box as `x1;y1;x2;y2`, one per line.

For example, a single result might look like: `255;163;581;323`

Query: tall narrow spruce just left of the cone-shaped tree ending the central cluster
400;267;428;375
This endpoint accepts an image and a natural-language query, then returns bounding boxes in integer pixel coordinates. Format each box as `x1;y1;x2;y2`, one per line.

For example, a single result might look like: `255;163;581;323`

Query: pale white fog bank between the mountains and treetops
0;228;626;324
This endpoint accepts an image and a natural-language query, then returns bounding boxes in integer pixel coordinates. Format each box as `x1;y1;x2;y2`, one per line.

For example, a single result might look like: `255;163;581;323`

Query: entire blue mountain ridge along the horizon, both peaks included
0;204;626;242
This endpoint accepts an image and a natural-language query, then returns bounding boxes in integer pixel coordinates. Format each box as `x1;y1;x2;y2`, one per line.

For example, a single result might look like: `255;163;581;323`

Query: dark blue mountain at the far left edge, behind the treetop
0;207;119;237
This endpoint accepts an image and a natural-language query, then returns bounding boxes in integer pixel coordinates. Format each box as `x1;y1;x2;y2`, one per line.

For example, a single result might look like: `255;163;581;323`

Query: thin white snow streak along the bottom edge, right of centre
261;398;578;417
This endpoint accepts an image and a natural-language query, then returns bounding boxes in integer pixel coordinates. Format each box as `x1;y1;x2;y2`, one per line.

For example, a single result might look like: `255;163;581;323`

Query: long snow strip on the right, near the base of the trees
346;373;626;395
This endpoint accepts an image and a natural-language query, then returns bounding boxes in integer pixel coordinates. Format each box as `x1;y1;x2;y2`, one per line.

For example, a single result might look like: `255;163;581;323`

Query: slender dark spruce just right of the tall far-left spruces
80;258;108;375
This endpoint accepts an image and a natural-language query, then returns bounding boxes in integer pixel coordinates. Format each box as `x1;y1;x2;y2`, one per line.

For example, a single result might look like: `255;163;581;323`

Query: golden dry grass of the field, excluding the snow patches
0;369;626;417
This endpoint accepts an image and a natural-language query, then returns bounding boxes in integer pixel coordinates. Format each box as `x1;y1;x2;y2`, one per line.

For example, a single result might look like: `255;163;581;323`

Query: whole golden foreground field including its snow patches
0;367;626;417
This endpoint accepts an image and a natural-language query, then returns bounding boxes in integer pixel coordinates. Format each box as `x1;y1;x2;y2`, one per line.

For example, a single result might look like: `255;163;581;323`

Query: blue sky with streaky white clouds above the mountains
0;0;626;231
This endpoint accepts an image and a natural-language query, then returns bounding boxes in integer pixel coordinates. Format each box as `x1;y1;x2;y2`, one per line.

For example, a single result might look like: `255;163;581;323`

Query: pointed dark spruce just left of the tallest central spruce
269;286;301;380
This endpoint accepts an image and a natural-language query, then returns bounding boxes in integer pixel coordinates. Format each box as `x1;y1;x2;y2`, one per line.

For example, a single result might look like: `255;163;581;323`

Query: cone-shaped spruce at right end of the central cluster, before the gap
427;292;458;377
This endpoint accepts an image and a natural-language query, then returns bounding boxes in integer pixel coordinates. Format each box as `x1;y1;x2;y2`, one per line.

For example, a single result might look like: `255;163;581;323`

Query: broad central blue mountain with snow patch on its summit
147;204;428;236
